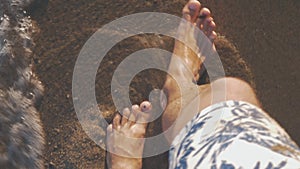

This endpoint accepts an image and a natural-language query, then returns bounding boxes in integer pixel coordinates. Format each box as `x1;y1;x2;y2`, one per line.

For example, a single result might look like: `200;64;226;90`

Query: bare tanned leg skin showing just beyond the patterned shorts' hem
162;78;261;143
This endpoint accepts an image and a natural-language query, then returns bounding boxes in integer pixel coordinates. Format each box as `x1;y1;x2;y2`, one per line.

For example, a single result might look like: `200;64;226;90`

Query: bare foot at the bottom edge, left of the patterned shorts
107;101;152;169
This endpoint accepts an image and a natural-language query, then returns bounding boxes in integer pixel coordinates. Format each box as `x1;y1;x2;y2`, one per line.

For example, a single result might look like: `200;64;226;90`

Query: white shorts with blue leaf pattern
169;101;300;169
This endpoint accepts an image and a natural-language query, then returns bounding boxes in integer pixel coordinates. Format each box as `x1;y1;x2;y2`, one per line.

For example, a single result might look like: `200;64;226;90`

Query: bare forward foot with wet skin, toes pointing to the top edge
169;0;217;84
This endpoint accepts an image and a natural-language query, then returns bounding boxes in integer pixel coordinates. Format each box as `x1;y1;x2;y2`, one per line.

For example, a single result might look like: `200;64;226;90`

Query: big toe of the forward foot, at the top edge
182;0;201;23
